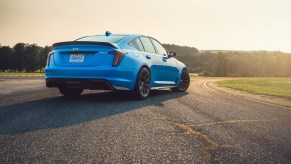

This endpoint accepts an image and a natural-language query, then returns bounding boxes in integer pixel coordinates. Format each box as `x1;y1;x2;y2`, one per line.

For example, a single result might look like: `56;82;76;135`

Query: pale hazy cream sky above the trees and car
0;0;291;52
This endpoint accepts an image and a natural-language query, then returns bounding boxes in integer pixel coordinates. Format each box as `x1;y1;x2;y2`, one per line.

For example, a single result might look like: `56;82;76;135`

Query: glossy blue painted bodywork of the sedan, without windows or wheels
45;31;186;90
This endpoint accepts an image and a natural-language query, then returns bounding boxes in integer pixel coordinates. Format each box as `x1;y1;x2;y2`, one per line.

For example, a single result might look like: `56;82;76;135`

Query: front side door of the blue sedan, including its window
151;38;179;84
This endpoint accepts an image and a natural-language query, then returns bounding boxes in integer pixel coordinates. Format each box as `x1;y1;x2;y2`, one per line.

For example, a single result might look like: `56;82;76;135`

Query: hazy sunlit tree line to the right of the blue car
165;44;291;77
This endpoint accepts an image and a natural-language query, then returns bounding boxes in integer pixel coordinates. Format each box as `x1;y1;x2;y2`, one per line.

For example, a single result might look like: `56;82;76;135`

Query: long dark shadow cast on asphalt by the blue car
0;90;188;135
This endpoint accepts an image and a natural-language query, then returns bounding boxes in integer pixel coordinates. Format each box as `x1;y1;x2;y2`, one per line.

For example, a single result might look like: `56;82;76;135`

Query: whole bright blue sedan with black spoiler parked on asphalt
45;32;190;99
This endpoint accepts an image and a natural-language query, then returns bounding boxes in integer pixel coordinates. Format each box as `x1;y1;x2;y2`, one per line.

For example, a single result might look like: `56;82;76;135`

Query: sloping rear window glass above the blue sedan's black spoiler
76;35;127;43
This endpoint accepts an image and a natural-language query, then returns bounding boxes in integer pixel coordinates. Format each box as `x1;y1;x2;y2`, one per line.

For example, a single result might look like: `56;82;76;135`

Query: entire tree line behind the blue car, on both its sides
0;43;291;76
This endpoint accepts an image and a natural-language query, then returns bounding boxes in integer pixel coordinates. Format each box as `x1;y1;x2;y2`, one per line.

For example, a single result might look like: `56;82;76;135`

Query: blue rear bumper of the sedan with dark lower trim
45;66;138;90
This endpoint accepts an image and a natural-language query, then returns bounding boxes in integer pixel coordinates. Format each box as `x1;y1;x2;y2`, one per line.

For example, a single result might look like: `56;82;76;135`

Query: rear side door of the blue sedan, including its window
139;36;163;87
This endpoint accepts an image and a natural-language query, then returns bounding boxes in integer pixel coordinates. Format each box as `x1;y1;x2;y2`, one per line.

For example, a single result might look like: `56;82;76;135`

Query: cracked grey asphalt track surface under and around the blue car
0;78;291;163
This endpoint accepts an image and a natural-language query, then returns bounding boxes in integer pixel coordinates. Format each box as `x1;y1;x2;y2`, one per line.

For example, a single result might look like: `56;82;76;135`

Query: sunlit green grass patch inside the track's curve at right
218;78;291;99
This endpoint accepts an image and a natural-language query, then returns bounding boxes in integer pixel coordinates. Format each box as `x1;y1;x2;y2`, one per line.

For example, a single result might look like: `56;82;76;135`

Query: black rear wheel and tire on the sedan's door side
133;67;151;100
